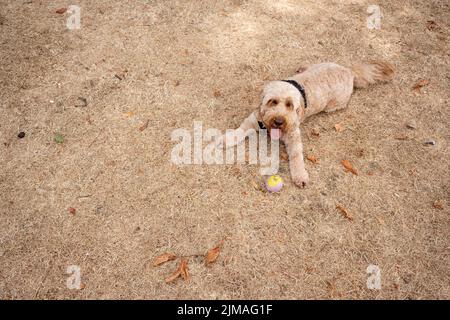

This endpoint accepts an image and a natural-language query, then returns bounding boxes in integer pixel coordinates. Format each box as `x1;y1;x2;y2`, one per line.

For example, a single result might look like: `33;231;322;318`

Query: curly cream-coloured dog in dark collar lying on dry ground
218;61;394;187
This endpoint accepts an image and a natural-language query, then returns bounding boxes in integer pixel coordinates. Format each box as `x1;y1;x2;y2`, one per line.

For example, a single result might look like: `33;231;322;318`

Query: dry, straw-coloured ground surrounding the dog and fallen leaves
0;0;450;299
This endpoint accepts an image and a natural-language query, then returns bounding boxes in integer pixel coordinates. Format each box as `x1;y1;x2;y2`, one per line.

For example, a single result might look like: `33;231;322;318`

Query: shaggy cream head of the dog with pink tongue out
259;81;303;139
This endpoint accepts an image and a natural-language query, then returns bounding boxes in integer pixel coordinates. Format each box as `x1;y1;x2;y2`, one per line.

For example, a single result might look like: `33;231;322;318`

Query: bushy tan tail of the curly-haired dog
351;61;395;88
